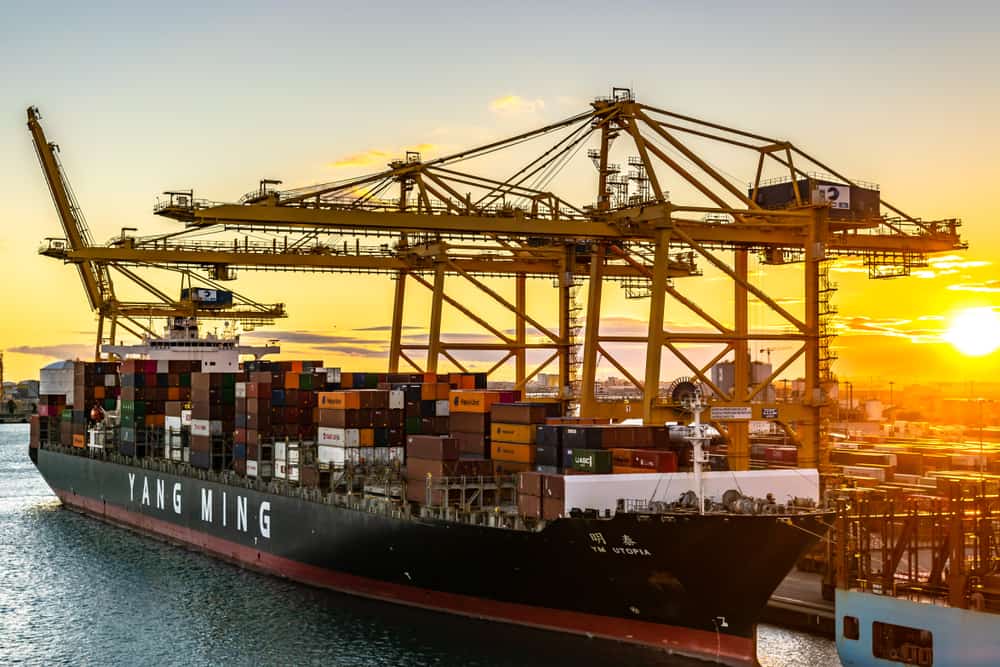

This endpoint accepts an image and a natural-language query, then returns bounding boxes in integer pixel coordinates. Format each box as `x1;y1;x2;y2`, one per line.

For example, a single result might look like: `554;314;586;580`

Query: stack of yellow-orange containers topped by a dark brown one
490;403;560;475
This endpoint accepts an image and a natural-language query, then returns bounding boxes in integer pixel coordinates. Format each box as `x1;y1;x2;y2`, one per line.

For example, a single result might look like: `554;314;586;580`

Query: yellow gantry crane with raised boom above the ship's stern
28;107;285;359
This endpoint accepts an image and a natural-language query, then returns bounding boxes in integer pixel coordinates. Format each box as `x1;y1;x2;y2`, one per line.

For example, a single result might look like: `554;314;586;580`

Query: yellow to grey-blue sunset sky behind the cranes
0;2;1000;383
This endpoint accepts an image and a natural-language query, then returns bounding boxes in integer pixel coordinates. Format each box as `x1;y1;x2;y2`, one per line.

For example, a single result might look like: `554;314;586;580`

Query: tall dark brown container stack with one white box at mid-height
191;373;236;471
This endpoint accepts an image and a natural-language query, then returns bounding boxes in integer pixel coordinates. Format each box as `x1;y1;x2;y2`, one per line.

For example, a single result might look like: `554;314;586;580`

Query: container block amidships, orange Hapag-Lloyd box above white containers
316;388;405;469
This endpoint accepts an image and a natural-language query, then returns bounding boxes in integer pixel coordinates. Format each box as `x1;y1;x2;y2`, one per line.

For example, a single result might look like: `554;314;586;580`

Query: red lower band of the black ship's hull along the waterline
56;490;759;666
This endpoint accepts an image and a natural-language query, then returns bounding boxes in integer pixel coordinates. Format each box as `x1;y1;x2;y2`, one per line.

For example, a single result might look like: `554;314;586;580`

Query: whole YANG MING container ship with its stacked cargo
30;321;832;665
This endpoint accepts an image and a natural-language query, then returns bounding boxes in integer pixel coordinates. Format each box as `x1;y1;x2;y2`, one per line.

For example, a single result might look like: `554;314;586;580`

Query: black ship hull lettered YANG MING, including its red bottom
37;449;825;665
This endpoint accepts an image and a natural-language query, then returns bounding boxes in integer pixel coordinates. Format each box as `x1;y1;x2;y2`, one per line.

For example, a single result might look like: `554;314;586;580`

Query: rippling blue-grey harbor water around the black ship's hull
0;425;840;667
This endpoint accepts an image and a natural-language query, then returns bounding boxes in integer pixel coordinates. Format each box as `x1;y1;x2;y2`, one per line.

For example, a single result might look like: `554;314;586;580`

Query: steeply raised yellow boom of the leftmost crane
28;107;114;311
